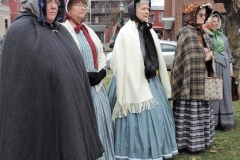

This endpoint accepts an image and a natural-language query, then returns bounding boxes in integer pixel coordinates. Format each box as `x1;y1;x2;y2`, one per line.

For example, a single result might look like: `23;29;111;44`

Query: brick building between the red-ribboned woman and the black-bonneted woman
84;0;128;42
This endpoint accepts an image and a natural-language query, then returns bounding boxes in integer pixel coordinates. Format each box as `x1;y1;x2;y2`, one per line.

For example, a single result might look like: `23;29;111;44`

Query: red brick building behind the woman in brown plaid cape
162;0;227;41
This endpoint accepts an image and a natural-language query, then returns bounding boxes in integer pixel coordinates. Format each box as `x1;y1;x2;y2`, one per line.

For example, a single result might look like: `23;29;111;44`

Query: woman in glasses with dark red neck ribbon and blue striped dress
62;0;114;160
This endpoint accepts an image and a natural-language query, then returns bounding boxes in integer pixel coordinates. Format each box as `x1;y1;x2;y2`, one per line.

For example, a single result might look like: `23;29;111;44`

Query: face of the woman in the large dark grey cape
46;0;60;24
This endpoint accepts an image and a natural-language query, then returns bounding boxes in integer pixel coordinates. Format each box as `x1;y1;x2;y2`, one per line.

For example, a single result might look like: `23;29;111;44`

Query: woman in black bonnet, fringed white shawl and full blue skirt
108;0;178;160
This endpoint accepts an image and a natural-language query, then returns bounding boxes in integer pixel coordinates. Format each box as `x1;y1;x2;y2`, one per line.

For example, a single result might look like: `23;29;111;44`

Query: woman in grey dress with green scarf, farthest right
204;11;234;129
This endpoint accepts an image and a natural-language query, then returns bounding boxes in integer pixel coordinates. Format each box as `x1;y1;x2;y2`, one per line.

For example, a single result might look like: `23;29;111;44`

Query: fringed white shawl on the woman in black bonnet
110;20;171;121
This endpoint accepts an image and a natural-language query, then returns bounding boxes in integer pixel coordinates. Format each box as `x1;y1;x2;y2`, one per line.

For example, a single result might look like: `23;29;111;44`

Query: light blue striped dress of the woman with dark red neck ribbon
77;31;115;160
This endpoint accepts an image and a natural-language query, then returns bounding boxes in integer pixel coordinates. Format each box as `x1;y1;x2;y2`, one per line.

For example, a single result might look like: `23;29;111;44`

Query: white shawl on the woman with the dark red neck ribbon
61;19;106;92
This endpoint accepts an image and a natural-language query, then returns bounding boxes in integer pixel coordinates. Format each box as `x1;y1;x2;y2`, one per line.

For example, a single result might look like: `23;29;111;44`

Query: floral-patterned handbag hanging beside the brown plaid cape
204;59;223;101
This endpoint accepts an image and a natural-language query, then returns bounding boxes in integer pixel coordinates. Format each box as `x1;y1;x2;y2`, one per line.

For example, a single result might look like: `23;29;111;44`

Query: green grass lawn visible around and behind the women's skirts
104;70;240;160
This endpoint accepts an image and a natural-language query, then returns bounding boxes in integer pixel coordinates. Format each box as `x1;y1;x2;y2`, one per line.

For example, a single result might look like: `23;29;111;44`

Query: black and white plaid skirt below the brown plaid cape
173;100;214;152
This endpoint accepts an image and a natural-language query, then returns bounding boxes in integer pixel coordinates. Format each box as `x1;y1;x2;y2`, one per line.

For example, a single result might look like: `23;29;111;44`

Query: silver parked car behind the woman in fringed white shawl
106;40;177;70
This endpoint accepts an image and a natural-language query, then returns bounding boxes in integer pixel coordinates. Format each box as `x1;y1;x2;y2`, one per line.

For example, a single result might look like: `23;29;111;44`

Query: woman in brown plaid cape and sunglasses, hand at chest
171;3;214;152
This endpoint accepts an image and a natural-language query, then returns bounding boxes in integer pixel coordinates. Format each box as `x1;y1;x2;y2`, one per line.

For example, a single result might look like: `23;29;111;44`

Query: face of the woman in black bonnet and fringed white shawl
136;4;149;22
